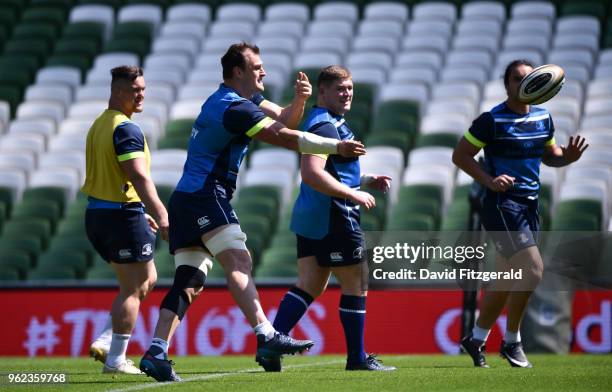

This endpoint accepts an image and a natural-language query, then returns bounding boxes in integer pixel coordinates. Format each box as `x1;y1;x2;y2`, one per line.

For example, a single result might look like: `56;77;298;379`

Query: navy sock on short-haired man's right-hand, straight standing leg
339;294;366;363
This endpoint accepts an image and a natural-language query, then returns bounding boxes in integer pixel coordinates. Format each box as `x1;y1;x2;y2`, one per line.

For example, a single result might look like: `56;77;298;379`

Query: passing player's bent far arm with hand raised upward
259;72;312;129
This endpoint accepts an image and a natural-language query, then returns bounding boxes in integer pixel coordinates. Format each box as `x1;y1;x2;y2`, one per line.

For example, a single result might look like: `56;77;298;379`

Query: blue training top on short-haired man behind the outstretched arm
290;106;361;239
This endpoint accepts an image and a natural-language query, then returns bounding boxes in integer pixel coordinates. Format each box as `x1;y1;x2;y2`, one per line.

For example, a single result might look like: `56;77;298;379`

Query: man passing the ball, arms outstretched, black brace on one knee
140;43;365;381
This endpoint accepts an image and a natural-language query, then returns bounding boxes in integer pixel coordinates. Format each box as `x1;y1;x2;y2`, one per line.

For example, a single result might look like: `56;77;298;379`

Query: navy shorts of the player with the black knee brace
168;189;239;254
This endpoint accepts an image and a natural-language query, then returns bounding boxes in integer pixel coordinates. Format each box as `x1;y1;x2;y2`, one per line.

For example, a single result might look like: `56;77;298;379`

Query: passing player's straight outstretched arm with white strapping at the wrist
253;121;366;157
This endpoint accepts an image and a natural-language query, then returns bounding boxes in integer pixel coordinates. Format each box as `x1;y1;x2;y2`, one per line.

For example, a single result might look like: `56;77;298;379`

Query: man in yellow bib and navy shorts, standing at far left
81;66;168;374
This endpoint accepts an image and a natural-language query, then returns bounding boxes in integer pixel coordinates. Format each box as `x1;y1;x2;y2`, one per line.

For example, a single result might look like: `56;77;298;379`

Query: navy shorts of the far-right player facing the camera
481;194;540;259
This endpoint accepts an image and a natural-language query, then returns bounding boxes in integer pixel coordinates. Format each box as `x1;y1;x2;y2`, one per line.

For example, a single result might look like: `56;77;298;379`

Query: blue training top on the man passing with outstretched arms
176;84;274;193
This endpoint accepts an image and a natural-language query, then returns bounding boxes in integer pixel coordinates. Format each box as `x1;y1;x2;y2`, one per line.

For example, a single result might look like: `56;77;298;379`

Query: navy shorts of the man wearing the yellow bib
85;208;155;264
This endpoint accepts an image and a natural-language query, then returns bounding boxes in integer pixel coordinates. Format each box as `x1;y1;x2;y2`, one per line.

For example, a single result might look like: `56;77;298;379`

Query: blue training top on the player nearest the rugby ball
464;102;555;199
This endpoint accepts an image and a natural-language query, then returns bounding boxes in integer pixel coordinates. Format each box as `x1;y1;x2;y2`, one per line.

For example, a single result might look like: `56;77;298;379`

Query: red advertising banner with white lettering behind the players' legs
0;288;612;357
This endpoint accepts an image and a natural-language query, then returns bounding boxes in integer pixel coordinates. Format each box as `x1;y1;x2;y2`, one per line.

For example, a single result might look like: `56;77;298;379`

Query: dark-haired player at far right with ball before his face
453;60;588;368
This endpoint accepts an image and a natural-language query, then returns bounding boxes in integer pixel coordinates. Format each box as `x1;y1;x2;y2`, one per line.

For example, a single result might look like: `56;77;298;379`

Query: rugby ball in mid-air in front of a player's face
518;64;565;105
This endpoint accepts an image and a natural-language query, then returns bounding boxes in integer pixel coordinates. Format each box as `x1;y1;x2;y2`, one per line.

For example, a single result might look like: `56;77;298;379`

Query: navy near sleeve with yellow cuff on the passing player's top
223;101;274;137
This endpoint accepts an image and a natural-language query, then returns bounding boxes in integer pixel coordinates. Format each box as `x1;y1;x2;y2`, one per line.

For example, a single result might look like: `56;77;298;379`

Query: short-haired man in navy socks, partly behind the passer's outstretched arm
260;65;395;371
